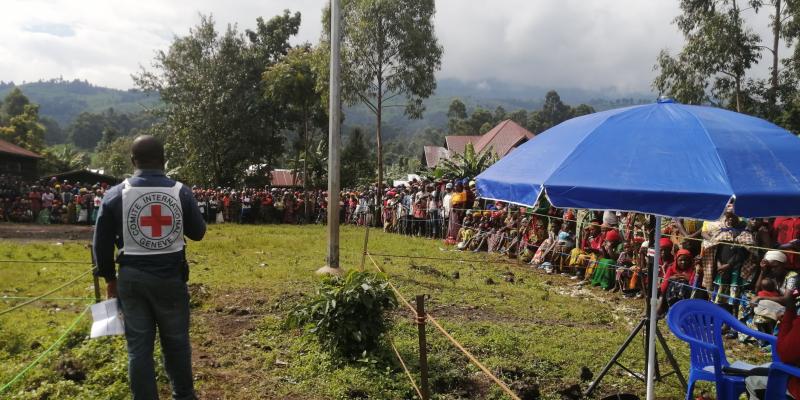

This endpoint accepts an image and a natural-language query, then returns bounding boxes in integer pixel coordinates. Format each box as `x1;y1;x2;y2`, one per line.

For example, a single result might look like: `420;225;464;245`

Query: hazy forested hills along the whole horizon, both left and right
0;79;654;137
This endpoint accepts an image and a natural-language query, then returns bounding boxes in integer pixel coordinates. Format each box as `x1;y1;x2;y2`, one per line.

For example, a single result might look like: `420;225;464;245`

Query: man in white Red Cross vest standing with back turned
93;136;206;400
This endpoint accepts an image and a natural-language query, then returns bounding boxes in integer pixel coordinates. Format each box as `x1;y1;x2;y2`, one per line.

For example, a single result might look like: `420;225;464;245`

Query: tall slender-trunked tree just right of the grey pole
323;0;442;191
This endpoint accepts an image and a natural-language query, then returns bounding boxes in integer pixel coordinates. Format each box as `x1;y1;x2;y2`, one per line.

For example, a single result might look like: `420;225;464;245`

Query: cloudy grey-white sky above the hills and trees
0;0;768;92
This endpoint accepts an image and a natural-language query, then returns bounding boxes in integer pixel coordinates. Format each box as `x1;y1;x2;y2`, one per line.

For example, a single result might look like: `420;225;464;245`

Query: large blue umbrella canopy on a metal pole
477;100;800;220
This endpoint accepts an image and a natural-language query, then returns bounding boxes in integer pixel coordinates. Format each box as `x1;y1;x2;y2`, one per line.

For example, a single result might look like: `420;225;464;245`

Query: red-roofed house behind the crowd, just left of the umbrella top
423;119;535;168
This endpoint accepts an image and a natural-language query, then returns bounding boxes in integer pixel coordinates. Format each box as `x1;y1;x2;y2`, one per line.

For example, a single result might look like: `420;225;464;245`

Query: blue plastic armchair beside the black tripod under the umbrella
667;300;778;400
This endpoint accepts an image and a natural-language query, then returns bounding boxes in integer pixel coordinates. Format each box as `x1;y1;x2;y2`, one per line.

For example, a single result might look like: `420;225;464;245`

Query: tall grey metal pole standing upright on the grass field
317;0;341;275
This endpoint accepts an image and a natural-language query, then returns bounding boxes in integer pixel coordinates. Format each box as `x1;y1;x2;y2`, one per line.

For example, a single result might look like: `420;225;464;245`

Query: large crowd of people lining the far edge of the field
0;176;800;346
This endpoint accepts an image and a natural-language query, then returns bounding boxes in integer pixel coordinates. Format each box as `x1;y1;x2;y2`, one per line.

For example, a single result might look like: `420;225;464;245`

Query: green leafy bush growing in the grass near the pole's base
287;270;397;359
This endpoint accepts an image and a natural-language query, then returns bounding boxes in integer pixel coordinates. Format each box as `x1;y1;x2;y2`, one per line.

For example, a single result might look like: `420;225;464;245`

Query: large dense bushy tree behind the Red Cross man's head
134;10;300;185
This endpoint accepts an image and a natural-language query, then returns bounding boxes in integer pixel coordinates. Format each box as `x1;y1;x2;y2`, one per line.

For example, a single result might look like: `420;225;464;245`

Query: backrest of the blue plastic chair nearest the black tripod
667;299;738;369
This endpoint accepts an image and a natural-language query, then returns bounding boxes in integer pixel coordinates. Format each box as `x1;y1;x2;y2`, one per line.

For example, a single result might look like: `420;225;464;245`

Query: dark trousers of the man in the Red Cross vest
117;266;195;400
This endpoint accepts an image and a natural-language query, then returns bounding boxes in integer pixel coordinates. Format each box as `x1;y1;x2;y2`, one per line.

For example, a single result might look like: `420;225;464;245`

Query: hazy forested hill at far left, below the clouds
0;79;160;126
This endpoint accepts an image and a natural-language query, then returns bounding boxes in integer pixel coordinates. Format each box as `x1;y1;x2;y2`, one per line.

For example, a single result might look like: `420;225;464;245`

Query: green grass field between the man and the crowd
0;225;776;399
